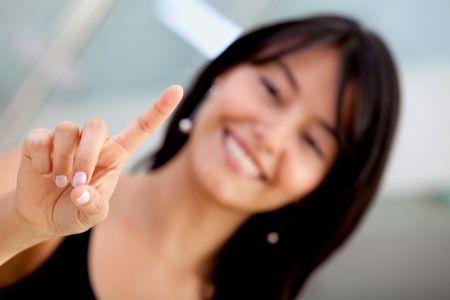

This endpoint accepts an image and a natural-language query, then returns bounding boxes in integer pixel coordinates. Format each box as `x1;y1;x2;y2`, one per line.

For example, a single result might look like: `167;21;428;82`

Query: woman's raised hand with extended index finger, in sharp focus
14;86;183;238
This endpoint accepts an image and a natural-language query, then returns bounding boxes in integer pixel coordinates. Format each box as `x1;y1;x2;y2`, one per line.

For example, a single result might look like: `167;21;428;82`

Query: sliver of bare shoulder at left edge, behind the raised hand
0;148;21;194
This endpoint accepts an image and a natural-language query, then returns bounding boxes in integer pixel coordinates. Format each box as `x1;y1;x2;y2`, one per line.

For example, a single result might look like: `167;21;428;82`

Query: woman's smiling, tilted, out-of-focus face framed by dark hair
186;46;348;213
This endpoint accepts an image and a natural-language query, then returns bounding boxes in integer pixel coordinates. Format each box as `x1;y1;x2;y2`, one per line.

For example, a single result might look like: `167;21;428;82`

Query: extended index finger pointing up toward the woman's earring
114;85;183;153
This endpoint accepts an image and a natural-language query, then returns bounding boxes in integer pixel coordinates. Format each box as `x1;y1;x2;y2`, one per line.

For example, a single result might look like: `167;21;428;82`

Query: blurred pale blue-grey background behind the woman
0;0;450;300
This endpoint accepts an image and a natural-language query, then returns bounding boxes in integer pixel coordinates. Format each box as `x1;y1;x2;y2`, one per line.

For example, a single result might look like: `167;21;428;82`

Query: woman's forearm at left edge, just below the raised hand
0;191;46;267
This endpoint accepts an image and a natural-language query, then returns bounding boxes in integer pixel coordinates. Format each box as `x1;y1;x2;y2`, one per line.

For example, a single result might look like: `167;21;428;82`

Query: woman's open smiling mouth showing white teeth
224;129;267;181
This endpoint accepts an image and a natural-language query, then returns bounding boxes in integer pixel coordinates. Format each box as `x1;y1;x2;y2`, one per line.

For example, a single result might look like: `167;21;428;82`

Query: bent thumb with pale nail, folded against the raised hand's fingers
70;185;109;229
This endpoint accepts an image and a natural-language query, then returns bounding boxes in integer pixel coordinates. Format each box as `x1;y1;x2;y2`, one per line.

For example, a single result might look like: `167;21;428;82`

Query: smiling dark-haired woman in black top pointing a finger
0;16;399;299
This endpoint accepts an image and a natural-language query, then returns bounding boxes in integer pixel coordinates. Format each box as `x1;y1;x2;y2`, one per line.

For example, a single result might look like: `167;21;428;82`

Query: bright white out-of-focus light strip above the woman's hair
155;0;242;58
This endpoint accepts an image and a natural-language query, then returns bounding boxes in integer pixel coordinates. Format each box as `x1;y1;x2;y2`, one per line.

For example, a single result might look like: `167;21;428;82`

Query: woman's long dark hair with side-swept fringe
151;15;399;299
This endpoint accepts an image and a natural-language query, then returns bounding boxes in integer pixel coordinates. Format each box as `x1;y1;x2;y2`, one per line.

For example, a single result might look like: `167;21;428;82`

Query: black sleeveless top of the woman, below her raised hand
0;230;95;300
